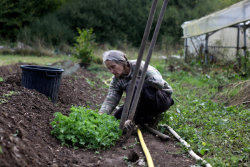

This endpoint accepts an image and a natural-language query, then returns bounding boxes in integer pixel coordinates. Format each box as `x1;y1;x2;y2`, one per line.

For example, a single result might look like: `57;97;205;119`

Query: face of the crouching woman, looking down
105;60;125;78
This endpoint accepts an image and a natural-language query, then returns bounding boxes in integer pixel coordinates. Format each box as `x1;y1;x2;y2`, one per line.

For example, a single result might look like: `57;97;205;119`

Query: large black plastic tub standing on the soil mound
21;65;64;103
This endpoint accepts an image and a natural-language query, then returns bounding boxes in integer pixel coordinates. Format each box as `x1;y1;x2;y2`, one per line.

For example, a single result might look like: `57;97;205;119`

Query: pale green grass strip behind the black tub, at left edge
0;55;75;66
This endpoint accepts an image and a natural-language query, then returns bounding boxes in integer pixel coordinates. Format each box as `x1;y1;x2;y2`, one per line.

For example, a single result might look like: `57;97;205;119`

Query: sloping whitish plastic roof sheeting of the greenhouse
181;0;250;38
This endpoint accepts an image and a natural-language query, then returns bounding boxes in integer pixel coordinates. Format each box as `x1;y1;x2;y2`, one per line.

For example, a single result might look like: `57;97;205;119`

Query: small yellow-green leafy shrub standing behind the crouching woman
73;28;94;65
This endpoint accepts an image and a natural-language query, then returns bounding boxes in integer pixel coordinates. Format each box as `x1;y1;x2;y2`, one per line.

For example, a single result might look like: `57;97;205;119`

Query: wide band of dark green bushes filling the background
11;0;239;48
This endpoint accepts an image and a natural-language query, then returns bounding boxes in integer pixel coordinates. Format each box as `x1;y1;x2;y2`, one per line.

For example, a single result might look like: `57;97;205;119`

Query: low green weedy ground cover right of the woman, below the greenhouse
159;71;250;167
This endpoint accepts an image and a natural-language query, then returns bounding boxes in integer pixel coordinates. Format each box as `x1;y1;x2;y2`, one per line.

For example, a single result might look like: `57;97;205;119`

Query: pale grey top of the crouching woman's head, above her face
102;50;127;63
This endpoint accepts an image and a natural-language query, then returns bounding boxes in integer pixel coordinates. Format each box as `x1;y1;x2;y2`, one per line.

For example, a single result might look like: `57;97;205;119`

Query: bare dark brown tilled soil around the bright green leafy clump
0;63;195;167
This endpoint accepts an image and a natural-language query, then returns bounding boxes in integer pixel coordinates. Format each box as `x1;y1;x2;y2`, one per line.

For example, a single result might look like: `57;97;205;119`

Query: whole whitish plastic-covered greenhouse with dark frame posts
182;0;250;69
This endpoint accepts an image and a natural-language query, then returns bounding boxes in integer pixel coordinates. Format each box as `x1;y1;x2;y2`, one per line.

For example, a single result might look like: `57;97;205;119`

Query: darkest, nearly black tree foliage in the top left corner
0;0;65;41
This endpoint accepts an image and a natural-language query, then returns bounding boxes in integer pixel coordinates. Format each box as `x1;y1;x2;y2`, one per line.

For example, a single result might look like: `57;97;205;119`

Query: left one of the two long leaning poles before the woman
120;0;158;129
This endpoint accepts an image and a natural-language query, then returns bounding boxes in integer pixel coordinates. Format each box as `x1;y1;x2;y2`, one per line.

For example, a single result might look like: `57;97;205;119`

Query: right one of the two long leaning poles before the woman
128;0;168;120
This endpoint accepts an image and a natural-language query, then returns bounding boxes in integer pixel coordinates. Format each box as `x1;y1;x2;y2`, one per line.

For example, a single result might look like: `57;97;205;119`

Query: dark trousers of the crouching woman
114;83;174;125
